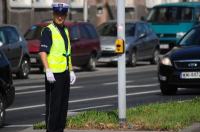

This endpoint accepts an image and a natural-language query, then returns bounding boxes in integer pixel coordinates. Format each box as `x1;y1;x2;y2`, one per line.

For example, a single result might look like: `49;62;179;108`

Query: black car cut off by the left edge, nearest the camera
0;48;15;127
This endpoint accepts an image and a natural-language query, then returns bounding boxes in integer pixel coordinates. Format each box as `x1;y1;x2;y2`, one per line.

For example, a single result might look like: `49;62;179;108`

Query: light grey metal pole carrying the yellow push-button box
117;0;126;127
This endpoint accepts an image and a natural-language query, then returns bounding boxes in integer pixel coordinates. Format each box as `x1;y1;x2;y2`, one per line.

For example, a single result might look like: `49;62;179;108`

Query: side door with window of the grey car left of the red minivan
0;26;22;70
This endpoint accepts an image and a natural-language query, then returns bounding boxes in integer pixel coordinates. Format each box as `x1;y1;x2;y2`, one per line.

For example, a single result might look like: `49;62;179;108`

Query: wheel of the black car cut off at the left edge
0;94;6;127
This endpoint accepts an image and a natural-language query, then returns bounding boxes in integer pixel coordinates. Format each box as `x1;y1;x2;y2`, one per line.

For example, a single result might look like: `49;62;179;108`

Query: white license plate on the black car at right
180;72;200;79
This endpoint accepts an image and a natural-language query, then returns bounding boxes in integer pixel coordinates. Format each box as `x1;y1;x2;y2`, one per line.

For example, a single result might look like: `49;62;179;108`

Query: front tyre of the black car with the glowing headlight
160;82;178;95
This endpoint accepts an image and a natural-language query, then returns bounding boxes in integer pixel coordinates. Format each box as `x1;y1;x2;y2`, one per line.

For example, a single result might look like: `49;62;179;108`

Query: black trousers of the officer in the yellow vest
45;70;70;132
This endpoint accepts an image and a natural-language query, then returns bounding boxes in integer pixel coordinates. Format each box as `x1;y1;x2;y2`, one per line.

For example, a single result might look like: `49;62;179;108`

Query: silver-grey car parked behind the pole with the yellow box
97;21;159;66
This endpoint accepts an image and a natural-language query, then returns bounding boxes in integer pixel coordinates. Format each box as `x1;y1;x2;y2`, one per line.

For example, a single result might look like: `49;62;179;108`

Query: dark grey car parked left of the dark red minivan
0;25;30;78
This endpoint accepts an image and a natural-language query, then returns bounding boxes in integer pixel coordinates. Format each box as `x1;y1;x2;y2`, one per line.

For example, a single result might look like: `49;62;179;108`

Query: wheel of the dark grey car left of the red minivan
17;58;30;79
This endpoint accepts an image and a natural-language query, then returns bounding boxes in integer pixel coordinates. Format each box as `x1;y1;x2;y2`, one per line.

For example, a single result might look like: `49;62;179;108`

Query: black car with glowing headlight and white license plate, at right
158;26;200;94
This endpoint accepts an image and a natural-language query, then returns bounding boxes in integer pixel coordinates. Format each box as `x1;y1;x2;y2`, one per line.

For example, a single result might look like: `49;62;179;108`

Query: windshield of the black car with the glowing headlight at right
179;28;200;46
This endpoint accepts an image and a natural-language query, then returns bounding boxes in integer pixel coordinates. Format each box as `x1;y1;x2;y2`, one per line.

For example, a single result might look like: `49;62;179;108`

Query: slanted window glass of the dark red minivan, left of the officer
24;26;43;40
